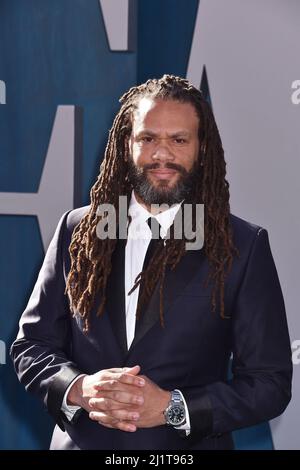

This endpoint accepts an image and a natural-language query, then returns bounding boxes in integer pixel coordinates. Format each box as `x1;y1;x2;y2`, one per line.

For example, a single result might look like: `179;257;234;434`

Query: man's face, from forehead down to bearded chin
129;98;199;205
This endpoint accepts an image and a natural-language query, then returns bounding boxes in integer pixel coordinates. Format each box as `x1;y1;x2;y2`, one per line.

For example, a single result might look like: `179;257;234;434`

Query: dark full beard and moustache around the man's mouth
128;157;200;206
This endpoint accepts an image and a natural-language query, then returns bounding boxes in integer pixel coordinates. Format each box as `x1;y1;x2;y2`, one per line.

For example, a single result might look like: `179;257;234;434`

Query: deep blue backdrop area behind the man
0;0;272;449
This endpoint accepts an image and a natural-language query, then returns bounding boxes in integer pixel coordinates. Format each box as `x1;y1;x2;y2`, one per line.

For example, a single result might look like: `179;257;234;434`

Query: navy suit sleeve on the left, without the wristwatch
10;213;82;430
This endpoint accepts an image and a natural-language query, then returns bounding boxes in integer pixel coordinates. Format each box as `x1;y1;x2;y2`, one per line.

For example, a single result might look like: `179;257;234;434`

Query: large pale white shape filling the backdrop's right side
187;0;300;449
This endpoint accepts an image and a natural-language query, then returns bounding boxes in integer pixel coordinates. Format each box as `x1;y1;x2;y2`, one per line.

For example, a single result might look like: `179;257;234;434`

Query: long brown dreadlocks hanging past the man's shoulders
66;75;238;331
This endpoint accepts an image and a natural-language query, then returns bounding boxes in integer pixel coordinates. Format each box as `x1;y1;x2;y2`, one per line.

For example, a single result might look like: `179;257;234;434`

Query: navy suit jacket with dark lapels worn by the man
11;206;292;450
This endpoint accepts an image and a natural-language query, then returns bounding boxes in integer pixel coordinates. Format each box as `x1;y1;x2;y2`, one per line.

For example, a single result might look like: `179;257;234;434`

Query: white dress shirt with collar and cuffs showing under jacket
61;191;190;434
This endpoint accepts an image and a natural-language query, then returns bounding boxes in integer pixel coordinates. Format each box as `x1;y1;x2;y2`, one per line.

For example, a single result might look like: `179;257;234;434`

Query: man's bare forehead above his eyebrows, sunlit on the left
132;97;199;132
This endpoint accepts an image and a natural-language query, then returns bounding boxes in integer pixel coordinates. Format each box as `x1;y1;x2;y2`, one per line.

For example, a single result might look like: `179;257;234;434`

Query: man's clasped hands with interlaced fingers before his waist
68;365;171;432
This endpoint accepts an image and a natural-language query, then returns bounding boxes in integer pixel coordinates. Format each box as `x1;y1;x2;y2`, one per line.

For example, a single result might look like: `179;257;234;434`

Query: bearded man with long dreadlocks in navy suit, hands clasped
11;75;292;450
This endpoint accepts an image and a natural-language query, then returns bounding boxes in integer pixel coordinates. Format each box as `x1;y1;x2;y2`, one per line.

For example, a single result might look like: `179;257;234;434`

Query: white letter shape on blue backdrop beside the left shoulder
0;106;75;251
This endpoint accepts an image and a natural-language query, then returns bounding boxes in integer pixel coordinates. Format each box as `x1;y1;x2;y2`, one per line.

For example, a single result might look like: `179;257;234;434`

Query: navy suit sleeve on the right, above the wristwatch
183;229;292;436
